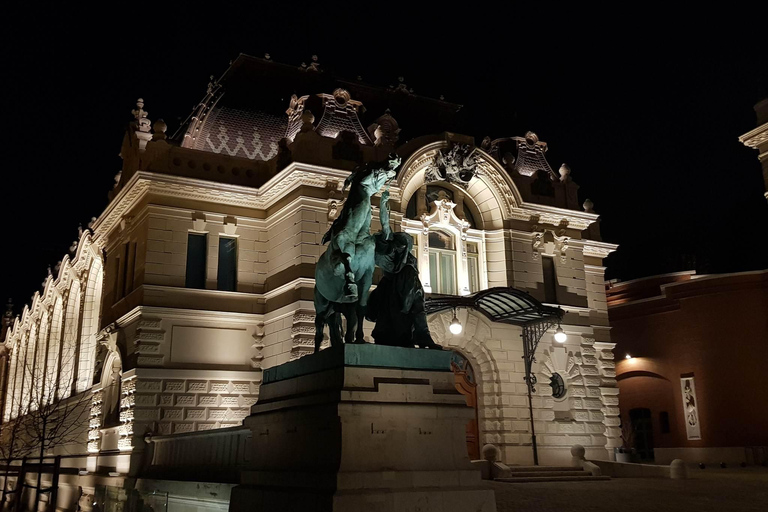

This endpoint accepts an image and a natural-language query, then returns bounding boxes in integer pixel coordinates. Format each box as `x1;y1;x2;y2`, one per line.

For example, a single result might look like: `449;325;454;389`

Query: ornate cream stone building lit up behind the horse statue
2;55;620;509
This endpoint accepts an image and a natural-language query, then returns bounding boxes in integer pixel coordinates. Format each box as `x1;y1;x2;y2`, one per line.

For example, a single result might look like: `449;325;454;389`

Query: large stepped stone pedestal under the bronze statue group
230;344;496;512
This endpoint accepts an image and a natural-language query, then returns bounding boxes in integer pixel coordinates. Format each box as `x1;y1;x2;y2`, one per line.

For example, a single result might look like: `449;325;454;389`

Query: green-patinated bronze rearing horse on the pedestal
315;154;401;352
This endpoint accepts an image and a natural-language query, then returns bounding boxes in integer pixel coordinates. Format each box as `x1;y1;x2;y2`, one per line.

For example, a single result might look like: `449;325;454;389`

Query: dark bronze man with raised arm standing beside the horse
365;190;442;349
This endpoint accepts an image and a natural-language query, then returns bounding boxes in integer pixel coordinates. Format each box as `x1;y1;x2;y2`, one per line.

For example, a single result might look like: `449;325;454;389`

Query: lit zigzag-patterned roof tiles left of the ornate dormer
194;107;288;160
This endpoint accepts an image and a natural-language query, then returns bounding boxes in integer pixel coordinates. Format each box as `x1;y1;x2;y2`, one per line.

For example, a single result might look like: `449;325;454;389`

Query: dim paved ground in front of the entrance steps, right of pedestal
486;468;768;512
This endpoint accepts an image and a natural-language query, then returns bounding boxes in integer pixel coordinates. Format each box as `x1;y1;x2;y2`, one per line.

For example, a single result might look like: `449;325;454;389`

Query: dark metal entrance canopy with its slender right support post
424;286;565;466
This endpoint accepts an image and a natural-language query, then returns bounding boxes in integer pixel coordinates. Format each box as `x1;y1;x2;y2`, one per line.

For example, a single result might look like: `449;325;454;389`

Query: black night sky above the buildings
0;7;768;311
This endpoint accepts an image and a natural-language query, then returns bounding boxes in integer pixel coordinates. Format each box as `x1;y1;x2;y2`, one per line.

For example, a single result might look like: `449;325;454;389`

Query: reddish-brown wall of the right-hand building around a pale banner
609;272;768;447
